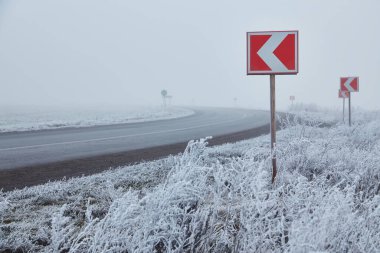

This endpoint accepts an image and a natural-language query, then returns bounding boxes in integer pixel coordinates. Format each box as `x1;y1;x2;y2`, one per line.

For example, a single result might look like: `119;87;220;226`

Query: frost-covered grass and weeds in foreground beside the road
0;111;380;252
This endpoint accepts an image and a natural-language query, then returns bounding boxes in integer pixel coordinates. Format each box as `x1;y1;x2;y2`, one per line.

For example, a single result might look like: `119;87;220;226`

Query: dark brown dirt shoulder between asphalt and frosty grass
0;124;270;191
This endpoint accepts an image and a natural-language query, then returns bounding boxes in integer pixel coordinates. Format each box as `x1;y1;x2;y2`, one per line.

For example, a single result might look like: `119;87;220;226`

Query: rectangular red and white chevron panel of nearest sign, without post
247;31;298;75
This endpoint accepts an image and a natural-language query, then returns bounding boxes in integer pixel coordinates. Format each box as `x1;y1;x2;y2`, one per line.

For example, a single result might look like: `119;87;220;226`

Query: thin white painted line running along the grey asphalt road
0;114;247;151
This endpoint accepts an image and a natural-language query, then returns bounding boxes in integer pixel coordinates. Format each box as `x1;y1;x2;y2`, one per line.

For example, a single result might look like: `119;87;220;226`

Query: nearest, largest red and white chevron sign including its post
247;31;298;183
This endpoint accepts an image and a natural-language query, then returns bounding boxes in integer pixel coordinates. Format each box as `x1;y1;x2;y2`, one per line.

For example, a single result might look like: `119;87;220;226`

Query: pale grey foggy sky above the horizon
0;0;380;109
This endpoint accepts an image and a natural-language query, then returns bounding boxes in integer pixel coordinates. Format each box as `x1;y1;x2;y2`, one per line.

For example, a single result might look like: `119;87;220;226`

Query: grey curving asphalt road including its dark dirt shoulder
0;108;269;190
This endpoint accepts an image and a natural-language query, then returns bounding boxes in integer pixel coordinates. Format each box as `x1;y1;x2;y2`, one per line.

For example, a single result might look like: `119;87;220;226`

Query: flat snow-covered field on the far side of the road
0;106;194;133
